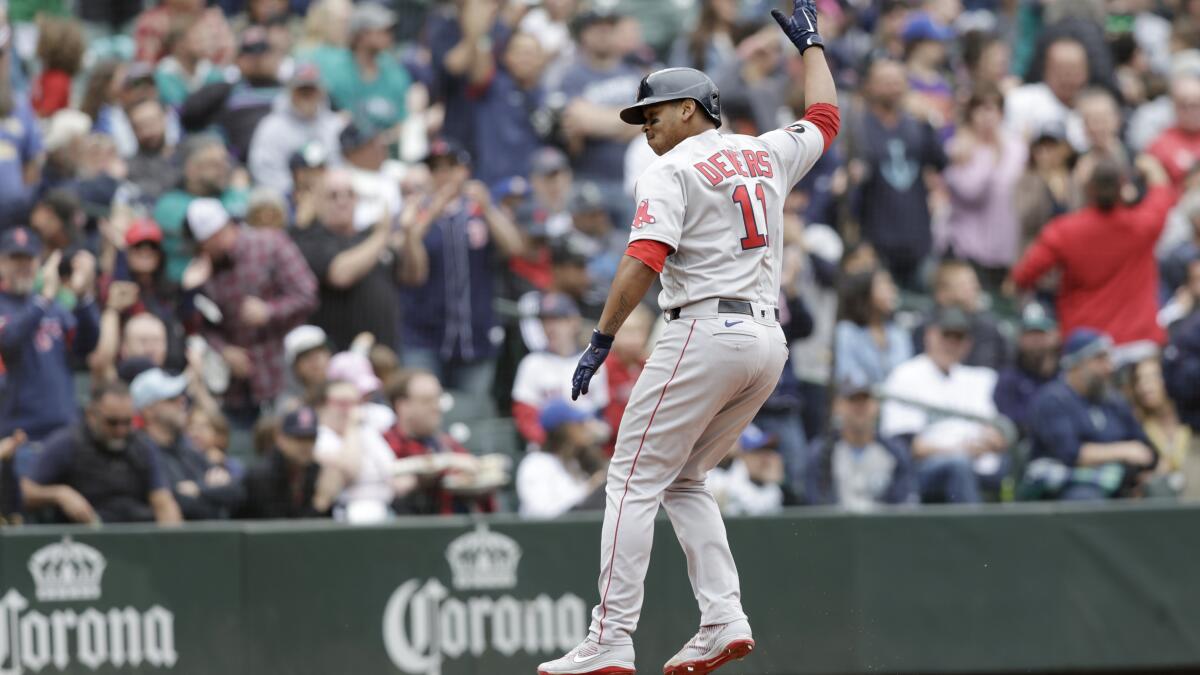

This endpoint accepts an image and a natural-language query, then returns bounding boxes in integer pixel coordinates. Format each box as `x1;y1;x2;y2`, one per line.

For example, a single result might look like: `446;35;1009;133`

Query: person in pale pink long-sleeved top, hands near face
944;91;1028;283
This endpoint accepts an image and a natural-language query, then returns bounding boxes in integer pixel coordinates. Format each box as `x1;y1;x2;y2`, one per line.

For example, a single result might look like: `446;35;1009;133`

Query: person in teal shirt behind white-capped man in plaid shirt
152;135;245;282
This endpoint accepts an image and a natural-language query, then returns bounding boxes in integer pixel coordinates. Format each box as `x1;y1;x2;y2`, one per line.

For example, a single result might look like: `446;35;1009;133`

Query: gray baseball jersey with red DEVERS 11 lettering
629;120;824;311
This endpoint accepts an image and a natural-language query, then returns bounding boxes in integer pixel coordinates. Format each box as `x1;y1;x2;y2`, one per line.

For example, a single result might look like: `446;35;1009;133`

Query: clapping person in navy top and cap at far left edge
0;227;100;441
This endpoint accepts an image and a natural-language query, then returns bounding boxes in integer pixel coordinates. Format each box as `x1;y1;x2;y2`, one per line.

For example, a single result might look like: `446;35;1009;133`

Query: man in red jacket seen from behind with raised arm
1013;155;1176;345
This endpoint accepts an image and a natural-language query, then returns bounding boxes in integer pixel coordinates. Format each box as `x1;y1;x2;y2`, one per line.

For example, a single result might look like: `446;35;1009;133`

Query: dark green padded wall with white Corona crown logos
0;504;1200;675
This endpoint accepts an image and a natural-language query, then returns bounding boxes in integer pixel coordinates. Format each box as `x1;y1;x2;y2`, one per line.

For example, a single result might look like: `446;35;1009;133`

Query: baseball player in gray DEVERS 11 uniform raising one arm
538;0;839;675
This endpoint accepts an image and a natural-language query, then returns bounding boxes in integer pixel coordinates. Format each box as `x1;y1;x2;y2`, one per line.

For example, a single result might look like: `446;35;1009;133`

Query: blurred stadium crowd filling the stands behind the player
0;0;1200;522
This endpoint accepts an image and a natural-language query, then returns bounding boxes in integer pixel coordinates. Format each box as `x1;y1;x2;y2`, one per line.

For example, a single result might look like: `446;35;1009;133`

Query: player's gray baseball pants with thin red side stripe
590;313;787;644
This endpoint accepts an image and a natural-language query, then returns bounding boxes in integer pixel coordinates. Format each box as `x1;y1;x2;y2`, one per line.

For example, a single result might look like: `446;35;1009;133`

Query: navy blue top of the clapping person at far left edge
0;293;100;441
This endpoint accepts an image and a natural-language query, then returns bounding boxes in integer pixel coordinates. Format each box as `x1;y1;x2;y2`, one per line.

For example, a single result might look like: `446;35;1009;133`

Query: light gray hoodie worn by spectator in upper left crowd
247;89;344;195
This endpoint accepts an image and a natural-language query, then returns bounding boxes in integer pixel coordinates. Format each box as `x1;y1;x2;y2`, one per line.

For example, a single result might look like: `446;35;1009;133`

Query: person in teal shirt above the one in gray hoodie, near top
306;2;412;127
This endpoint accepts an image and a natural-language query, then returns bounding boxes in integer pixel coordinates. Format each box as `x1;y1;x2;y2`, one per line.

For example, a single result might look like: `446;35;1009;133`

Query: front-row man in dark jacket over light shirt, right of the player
805;380;917;510
